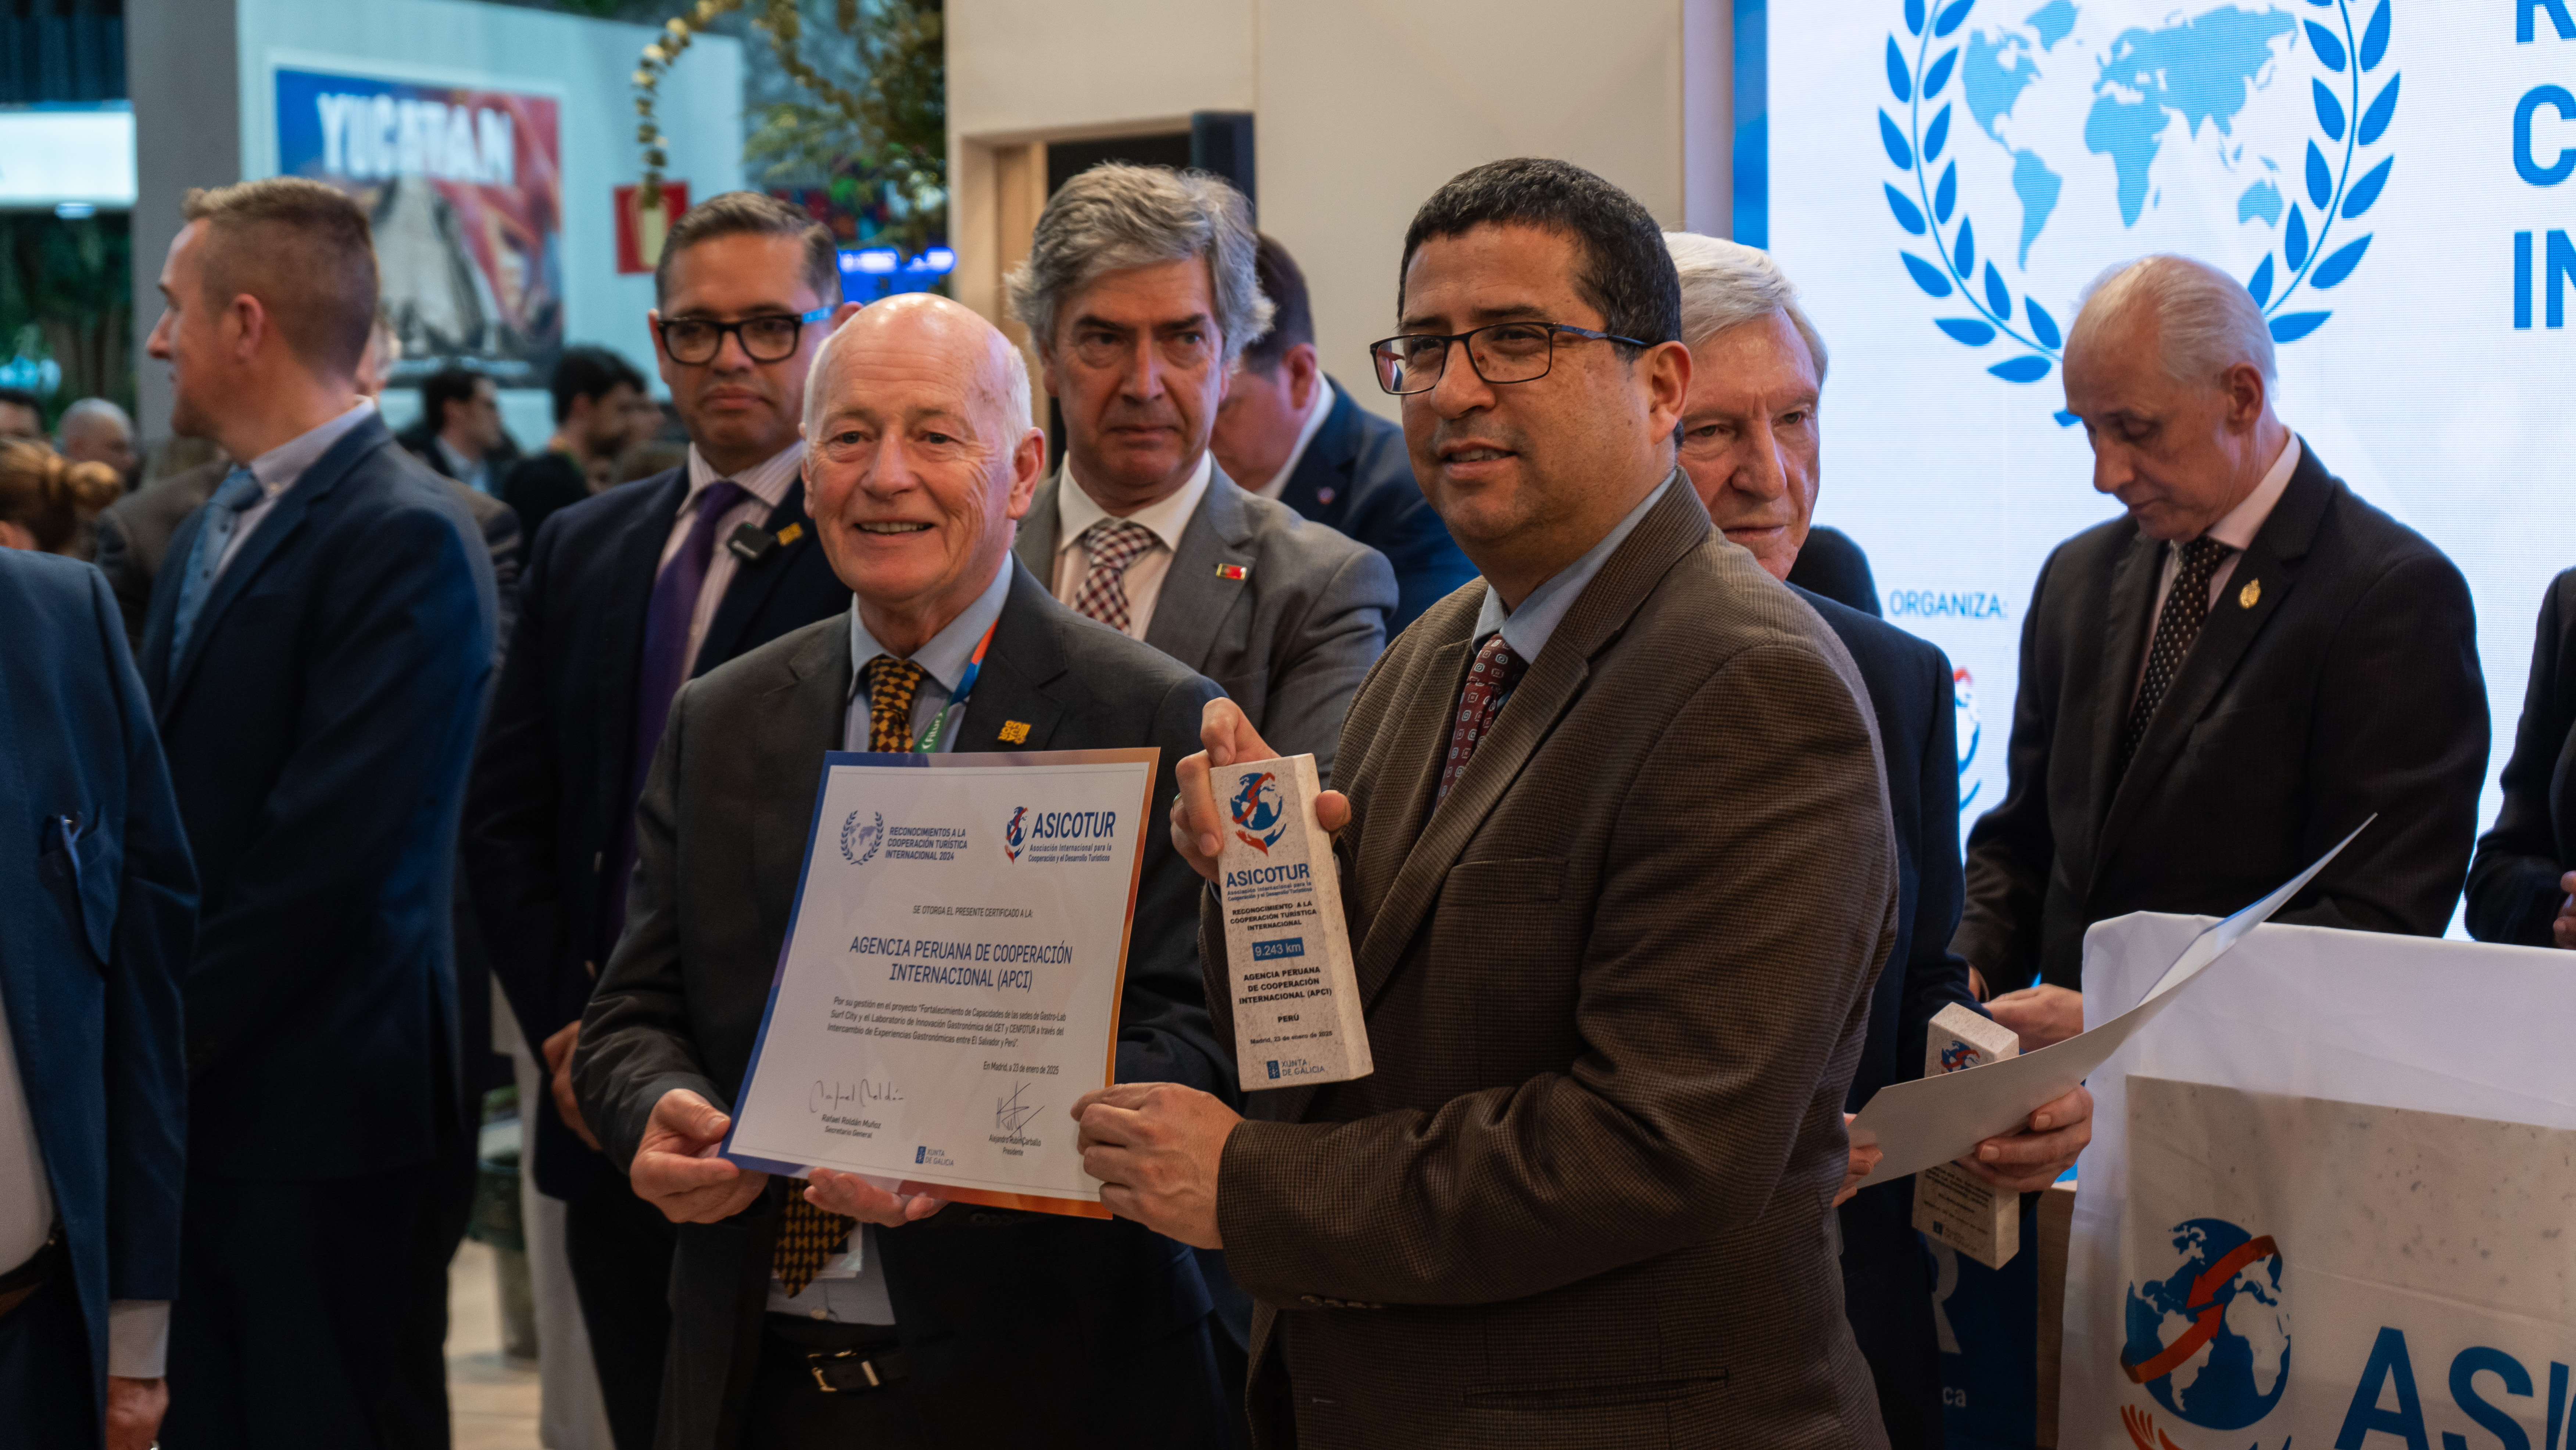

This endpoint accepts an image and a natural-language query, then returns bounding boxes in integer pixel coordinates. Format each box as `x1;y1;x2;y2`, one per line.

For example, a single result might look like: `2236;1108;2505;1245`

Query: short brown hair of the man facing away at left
178;175;376;376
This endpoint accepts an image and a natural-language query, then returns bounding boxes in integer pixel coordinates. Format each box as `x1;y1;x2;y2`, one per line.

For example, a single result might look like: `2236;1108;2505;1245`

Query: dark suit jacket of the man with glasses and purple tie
464;469;850;1197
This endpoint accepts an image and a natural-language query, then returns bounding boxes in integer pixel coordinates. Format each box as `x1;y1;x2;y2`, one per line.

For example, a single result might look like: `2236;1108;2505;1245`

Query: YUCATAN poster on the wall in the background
276;67;564;389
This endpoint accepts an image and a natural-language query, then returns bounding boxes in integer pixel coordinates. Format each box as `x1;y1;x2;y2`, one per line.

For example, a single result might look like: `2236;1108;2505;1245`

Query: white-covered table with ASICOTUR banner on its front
2058;914;2576;1450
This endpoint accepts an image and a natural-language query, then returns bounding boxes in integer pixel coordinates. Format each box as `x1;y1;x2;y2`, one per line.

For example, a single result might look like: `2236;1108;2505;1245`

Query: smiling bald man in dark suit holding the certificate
572;296;1234;1450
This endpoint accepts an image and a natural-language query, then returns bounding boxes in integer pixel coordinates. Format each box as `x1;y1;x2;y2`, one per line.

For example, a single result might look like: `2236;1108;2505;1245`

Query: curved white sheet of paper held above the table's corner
1852;817;2378;1185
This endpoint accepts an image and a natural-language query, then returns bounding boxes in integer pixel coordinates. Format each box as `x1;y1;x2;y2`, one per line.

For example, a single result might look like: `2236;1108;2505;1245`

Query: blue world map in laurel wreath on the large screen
1878;0;2401;401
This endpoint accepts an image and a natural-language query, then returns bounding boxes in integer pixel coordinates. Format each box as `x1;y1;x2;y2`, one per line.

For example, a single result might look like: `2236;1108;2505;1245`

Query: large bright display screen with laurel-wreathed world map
1736;0;2576;850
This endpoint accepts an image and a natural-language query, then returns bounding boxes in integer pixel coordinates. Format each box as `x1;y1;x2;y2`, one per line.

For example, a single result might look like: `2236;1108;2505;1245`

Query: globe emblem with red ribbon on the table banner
2120;1218;2290;1429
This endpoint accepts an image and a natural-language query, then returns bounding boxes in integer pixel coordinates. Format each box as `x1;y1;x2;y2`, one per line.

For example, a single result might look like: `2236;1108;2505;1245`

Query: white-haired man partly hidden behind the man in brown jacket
1664;232;2092;1450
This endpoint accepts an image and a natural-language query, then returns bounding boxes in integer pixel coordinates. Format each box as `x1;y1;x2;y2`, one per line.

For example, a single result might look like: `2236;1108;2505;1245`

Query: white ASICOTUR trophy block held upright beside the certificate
1211;755;1375;1089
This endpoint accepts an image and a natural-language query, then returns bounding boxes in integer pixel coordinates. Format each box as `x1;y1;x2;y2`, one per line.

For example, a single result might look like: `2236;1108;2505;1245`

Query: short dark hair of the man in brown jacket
1396;157;1682;356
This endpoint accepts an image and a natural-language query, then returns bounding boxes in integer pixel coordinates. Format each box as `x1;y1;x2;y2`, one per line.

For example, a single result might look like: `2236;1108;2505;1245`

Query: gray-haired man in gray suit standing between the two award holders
1010;162;1396;775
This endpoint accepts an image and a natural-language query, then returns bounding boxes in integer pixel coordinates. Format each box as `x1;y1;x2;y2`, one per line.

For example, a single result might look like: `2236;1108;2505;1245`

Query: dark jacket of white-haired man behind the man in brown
1790;582;1978;1450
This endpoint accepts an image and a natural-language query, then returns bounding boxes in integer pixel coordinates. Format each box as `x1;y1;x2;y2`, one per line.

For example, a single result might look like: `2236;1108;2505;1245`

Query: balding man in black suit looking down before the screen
1950;258;2489;1048
